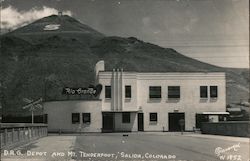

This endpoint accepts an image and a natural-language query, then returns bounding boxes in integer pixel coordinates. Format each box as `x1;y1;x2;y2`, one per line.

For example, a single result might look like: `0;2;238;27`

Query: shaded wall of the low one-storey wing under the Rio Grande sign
44;100;102;132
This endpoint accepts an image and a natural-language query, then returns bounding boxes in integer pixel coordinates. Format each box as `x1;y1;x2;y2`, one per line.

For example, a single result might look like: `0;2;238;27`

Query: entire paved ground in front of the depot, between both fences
2;133;249;161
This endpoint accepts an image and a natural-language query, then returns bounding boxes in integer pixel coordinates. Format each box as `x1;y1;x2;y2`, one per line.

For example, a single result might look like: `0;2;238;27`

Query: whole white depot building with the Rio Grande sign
44;61;228;132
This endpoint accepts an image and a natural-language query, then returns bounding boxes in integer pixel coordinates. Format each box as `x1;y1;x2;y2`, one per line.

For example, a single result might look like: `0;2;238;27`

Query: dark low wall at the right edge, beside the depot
201;121;250;137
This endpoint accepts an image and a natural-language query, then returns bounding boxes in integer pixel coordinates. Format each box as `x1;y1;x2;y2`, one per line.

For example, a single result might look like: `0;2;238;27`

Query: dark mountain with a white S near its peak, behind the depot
0;15;249;114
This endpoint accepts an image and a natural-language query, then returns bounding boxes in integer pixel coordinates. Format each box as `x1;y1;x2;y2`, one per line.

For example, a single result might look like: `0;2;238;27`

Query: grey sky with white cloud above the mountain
1;0;249;68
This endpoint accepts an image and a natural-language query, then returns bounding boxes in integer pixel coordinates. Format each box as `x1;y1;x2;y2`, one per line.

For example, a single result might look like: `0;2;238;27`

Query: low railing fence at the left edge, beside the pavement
0;123;47;148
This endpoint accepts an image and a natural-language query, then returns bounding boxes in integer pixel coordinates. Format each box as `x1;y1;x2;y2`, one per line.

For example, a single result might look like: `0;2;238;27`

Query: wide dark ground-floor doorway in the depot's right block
168;113;185;131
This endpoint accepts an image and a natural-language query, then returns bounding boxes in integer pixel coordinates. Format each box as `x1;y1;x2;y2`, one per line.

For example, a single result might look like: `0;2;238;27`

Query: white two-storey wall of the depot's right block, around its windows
137;73;226;131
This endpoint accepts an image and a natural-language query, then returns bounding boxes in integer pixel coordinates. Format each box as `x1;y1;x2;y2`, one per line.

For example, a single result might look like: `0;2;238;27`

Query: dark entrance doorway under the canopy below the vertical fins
102;112;114;132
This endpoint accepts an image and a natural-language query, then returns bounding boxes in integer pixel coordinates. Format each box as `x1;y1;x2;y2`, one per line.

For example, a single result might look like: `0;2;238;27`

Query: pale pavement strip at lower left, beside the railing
1;135;76;161
